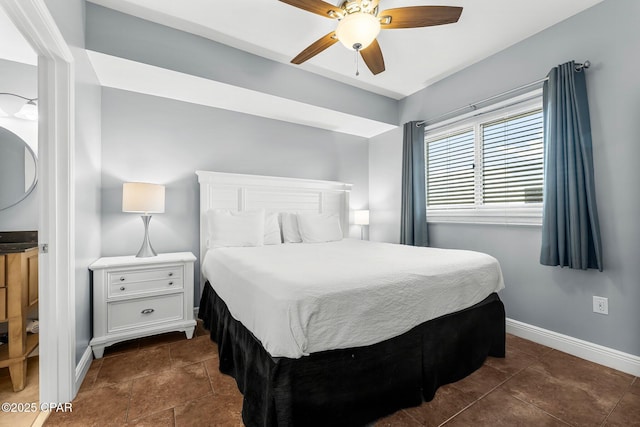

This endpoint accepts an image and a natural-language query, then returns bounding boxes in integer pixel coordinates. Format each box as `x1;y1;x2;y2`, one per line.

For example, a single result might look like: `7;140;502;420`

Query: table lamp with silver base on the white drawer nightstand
122;182;164;258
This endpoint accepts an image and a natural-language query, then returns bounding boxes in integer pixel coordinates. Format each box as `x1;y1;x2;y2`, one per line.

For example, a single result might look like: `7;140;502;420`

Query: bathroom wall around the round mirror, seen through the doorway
0;59;38;231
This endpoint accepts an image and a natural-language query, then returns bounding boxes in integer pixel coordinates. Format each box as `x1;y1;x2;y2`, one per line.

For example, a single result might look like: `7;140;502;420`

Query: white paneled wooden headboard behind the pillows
196;171;351;274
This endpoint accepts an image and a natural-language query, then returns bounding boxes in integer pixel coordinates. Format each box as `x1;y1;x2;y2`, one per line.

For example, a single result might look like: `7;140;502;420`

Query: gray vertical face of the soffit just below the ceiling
86;3;398;124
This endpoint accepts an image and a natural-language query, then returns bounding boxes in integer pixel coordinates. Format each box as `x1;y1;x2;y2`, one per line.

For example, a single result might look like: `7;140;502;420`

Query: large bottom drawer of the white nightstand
107;293;184;332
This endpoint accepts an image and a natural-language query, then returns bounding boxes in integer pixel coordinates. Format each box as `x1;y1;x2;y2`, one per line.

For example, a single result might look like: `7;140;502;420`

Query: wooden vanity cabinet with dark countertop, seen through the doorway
0;246;38;391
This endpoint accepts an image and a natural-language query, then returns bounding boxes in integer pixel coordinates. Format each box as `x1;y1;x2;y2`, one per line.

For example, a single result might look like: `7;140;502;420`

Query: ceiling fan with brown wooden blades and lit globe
280;0;462;75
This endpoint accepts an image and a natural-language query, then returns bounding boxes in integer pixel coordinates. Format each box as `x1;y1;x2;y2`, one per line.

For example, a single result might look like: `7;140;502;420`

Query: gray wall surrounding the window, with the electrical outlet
370;0;640;355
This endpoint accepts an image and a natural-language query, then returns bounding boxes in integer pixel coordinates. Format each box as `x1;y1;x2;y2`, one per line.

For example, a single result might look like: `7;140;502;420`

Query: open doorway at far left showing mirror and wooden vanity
0;5;40;426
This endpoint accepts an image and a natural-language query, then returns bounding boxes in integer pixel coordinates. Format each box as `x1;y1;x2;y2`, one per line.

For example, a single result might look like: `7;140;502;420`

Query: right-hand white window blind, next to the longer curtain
481;110;544;204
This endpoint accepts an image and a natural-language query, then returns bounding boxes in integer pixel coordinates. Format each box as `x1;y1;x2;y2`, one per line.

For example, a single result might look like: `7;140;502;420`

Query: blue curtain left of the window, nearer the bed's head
400;122;429;246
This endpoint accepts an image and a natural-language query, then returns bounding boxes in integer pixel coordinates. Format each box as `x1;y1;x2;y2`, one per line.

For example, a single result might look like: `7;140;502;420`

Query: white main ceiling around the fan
91;0;602;99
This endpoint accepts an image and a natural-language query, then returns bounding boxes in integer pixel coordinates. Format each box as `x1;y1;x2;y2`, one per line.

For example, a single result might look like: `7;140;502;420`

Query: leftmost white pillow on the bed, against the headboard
207;209;264;249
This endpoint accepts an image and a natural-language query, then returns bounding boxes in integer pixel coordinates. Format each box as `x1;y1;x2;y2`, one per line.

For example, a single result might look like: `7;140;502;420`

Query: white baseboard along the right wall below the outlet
507;319;640;376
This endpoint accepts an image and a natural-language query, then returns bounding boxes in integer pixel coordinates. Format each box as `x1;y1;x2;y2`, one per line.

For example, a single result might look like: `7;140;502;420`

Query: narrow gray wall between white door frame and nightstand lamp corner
46;0;102;364
